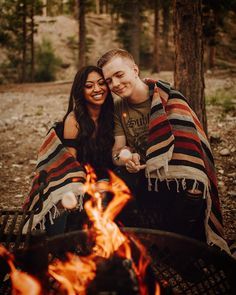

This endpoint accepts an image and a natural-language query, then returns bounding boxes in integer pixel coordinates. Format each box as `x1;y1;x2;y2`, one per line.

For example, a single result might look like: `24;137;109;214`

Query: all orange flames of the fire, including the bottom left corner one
0;165;160;295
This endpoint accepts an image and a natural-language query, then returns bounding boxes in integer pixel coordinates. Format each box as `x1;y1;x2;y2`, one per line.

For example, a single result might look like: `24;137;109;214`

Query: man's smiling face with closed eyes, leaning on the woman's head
102;57;138;98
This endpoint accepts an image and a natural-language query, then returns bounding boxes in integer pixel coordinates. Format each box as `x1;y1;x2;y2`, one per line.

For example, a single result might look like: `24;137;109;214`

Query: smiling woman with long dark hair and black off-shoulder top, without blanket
63;66;114;168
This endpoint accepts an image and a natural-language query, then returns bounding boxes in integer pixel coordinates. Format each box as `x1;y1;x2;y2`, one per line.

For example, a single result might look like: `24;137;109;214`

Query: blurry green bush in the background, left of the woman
35;39;62;82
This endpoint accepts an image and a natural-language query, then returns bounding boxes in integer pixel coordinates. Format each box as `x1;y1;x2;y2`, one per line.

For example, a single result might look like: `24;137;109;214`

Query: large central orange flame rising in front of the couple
49;166;160;295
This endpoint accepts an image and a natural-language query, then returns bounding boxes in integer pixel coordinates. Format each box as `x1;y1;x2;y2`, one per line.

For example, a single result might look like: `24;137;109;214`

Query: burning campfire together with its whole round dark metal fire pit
0;166;236;295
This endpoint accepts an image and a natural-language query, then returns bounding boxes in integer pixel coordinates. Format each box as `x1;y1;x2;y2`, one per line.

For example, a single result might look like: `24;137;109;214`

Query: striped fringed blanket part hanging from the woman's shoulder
23;124;86;232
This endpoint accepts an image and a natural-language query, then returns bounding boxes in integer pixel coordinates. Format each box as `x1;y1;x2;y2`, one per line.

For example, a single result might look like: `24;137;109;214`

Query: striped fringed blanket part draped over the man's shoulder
145;79;229;252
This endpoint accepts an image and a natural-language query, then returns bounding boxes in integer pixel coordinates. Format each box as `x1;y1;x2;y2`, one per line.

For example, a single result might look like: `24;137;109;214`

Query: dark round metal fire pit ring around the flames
47;228;236;295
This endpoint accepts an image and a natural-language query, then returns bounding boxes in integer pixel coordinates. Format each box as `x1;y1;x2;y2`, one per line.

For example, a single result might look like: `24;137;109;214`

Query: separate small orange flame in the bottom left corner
0;245;42;295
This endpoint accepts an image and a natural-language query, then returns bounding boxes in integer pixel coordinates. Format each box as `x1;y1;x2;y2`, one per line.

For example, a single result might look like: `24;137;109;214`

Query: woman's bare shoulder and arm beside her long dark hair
63;112;79;158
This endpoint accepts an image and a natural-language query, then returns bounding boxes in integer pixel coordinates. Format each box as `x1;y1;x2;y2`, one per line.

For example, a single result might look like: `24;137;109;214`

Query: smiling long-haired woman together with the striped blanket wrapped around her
24;66;114;235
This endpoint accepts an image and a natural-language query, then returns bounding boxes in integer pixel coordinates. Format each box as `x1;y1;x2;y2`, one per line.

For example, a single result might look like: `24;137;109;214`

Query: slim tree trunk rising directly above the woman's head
78;0;86;68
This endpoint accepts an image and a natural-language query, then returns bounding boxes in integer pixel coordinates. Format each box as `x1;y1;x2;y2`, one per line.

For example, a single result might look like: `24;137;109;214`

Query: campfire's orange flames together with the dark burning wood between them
0;166;160;295
